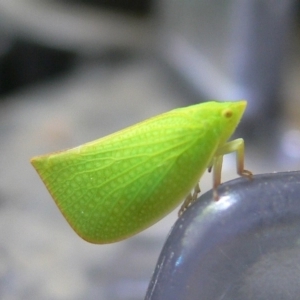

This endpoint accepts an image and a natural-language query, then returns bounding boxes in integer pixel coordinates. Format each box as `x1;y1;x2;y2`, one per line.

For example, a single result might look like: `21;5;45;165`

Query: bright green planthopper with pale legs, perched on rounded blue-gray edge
31;101;252;244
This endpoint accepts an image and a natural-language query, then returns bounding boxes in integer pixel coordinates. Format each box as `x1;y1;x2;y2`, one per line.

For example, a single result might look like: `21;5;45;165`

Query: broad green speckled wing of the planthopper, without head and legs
34;111;213;242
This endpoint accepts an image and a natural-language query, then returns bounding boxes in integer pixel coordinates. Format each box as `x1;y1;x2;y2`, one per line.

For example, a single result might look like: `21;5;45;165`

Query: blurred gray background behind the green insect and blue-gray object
0;0;300;300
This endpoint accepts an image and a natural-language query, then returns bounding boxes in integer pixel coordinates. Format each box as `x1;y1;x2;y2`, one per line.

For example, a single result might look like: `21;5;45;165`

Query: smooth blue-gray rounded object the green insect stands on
145;172;300;300
